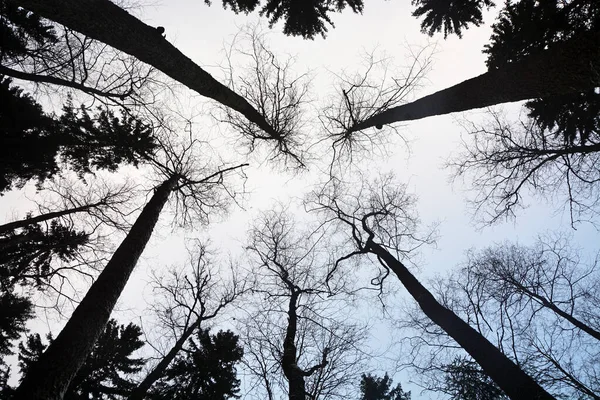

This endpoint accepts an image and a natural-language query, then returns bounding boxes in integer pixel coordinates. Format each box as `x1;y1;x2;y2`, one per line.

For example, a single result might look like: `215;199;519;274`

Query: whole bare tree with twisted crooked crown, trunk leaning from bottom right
308;176;553;399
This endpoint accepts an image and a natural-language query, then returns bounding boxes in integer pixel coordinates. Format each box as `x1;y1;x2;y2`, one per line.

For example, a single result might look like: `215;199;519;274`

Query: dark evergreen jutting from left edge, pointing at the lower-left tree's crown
0;77;156;193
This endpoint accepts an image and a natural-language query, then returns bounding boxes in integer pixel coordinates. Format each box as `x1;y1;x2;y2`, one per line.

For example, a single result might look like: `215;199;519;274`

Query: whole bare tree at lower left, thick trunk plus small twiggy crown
16;119;246;399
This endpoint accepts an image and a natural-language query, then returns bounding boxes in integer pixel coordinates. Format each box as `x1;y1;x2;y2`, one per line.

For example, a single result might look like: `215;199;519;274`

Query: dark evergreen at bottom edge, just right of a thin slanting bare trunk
150;329;244;400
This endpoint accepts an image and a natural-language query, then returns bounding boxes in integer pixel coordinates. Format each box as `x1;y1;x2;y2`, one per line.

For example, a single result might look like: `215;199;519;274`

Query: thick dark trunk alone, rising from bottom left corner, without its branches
14;177;178;400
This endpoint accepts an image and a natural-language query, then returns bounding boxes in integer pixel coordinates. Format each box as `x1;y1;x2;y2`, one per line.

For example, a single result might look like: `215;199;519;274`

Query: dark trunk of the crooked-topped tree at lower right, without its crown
368;241;554;400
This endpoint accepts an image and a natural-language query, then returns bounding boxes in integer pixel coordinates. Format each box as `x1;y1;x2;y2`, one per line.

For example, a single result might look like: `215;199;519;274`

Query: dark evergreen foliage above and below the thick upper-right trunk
484;0;600;144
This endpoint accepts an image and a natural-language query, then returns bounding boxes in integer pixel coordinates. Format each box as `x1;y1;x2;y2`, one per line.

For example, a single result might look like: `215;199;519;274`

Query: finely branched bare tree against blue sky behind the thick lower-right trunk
399;237;600;399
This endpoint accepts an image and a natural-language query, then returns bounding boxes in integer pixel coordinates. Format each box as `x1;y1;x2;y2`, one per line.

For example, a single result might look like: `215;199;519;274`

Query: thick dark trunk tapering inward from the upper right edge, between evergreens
351;32;600;131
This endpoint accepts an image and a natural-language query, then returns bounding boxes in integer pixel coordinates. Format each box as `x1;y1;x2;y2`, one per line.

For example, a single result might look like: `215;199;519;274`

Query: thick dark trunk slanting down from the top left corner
10;0;280;138
